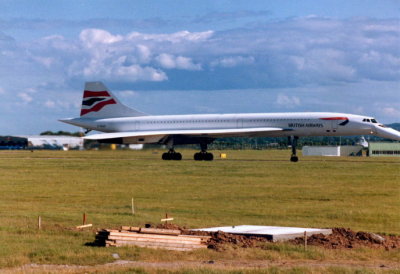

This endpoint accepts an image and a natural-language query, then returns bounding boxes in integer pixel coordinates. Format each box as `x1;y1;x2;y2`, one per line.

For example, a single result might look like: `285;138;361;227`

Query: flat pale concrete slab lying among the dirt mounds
192;225;332;242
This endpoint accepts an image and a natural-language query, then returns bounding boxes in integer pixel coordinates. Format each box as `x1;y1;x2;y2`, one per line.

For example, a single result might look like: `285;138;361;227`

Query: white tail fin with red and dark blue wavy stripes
81;82;147;118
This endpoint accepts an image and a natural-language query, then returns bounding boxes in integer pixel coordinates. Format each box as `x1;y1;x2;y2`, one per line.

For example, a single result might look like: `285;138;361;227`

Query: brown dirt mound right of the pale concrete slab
289;228;400;250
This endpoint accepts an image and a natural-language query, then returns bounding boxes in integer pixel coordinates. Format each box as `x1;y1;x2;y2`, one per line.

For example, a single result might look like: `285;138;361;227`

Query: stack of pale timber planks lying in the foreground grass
96;226;210;251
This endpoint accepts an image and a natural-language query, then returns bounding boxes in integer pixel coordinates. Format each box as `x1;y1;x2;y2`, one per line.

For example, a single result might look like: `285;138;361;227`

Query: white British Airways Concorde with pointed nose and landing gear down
60;82;400;162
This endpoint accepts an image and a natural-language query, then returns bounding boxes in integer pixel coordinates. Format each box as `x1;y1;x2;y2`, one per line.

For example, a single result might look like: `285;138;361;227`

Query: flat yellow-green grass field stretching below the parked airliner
0;150;400;273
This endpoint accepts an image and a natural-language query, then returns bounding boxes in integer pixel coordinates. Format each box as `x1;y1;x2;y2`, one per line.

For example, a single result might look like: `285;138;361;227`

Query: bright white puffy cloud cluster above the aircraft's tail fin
68;29;213;82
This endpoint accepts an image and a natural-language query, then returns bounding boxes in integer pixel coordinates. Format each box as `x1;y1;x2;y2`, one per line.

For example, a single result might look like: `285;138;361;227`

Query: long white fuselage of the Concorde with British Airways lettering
65;112;390;142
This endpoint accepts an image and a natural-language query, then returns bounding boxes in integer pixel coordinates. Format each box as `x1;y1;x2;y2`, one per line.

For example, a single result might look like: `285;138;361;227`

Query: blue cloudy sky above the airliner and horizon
0;0;400;135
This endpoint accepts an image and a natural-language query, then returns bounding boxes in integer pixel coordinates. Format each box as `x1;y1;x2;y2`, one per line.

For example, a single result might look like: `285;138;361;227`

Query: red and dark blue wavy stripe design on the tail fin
81;90;117;116
